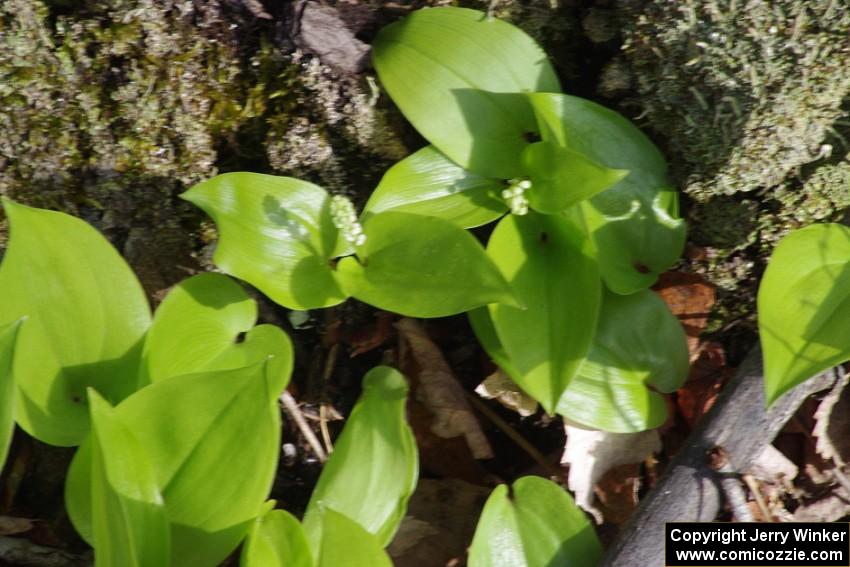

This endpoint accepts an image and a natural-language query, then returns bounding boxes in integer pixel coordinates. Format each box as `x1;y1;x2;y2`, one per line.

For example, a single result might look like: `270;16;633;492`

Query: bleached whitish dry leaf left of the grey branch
561;422;661;524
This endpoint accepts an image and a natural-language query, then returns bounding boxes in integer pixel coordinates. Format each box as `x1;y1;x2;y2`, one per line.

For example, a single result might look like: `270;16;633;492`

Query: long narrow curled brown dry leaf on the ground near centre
395;317;493;459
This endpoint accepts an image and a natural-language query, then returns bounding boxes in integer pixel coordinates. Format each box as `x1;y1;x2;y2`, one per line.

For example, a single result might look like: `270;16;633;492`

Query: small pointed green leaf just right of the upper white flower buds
522;142;629;214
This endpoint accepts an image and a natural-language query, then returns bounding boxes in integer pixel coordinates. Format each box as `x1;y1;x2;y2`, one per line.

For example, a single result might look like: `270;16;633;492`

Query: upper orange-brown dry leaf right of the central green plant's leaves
652;272;715;361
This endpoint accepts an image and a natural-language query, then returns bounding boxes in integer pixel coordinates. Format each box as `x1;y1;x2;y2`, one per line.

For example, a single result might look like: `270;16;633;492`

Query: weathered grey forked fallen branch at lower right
600;347;834;567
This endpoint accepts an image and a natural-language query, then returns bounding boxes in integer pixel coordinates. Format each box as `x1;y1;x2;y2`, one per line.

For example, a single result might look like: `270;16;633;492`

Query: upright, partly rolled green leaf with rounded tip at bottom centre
304;366;419;546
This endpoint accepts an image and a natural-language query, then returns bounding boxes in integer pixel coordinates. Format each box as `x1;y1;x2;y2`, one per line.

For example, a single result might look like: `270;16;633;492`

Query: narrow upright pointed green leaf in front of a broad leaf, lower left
89;389;171;567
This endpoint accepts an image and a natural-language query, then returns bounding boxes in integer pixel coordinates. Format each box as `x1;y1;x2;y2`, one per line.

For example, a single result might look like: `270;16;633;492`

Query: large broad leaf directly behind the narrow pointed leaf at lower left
65;363;280;567
